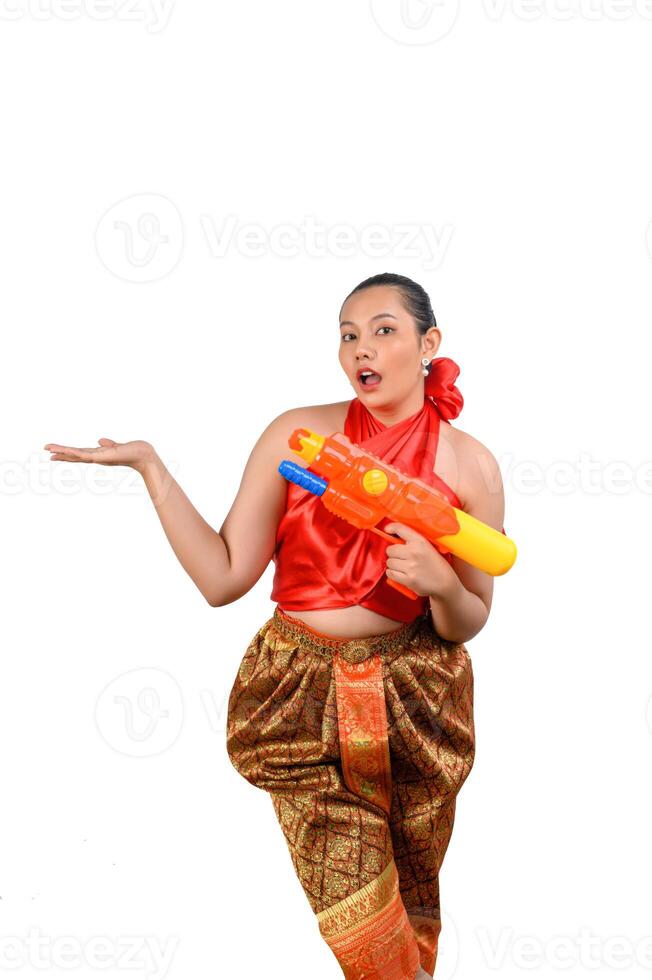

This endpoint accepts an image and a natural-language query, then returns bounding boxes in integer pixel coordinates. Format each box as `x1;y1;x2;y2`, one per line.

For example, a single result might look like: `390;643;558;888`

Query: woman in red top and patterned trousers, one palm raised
45;273;504;980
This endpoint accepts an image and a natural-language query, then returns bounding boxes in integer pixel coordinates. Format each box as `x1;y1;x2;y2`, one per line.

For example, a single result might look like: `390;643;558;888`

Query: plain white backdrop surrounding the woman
0;0;652;980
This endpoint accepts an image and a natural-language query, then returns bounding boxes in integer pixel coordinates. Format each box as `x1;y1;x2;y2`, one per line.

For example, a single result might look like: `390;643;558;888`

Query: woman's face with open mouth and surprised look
339;286;441;407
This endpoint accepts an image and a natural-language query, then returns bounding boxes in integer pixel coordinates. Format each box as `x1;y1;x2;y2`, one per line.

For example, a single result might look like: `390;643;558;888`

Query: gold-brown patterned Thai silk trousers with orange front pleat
227;606;475;980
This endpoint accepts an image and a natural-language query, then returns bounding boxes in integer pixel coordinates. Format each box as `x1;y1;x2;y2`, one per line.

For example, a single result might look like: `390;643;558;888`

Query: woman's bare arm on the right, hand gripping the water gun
384;436;505;643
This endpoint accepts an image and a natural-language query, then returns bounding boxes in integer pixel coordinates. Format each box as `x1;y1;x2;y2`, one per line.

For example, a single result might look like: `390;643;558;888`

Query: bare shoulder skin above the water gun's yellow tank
450;425;505;530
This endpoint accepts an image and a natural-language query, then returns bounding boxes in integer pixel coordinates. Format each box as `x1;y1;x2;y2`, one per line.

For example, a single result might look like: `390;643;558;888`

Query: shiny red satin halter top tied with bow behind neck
270;357;494;623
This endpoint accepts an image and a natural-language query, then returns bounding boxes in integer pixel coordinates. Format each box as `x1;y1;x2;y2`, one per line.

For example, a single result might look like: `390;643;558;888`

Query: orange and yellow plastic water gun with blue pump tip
278;428;516;599
